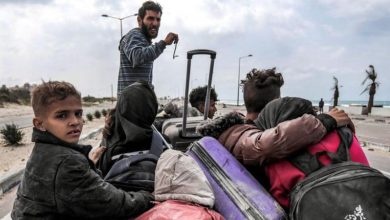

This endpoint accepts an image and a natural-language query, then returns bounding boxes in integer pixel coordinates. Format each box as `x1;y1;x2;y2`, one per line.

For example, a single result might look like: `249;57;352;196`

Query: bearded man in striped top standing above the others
118;1;179;97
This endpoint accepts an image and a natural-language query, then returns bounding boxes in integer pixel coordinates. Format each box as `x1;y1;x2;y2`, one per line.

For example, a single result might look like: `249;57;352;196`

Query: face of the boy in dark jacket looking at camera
33;96;83;144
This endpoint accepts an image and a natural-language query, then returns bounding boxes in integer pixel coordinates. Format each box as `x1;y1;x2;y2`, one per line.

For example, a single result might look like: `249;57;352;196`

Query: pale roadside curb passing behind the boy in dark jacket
0;127;103;196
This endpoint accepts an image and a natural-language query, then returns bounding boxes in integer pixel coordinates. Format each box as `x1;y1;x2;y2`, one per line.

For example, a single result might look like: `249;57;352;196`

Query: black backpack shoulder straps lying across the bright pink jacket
287;127;353;176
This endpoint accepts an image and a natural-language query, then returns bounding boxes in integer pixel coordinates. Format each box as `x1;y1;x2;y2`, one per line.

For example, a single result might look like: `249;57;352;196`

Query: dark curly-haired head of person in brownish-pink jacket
242;67;284;113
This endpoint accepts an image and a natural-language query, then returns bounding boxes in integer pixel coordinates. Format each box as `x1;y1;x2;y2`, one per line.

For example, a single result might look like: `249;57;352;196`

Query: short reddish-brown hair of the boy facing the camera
31;81;81;116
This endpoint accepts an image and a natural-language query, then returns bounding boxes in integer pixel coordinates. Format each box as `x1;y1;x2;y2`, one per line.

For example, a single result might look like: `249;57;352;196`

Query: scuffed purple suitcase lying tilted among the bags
187;137;287;220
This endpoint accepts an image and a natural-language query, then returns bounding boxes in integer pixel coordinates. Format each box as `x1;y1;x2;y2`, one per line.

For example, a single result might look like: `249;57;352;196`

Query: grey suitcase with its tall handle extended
161;49;217;151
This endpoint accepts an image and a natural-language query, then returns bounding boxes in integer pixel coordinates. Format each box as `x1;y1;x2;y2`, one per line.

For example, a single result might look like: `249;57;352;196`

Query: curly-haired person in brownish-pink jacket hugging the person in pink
197;68;352;170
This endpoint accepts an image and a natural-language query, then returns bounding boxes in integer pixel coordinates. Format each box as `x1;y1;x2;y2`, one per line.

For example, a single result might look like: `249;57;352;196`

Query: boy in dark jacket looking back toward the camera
12;81;153;219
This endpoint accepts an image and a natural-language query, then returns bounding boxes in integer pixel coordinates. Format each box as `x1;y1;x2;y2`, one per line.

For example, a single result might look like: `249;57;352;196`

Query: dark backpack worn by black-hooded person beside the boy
104;131;167;192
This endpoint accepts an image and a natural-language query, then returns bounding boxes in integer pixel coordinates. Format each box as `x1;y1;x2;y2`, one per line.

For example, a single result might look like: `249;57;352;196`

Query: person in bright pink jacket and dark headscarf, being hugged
254;97;368;209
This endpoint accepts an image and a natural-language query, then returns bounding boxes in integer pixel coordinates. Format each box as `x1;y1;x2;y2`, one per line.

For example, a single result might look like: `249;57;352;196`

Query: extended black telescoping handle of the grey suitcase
181;49;217;137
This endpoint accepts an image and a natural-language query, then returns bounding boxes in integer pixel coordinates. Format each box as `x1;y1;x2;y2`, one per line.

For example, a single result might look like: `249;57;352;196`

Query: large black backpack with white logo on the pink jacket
289;128;390;220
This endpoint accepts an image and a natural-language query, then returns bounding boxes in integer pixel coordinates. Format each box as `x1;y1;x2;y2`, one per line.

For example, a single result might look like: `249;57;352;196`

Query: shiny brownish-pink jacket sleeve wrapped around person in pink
232;114;327;165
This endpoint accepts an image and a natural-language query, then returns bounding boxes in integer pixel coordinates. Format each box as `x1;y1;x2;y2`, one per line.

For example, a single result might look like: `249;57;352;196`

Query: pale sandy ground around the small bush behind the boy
0;105;104;177
